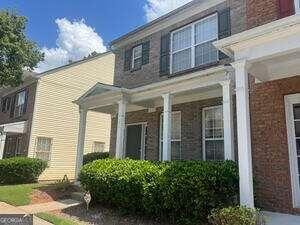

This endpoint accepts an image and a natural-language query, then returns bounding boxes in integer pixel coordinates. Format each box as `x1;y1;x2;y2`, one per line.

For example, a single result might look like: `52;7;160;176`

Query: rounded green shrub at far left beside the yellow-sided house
0;157;47;184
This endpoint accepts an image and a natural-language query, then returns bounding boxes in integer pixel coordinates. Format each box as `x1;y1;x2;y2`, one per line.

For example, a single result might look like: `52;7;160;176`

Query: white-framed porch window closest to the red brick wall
203;106;224;160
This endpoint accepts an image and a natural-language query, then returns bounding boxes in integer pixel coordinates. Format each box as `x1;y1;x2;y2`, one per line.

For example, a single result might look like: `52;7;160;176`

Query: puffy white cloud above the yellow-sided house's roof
36;18;106;72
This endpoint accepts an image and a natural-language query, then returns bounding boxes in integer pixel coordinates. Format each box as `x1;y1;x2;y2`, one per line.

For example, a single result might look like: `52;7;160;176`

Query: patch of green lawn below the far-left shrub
0;184;45;206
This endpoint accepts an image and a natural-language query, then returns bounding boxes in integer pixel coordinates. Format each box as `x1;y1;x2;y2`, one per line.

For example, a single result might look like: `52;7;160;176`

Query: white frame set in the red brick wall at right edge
284;93;300;208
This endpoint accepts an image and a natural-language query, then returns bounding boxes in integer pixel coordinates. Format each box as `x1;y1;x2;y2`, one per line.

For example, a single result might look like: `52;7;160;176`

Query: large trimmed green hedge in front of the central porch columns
80;159;238;224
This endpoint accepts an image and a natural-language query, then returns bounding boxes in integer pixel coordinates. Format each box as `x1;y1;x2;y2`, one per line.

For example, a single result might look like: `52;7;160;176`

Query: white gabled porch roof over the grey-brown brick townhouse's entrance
75;66;232;114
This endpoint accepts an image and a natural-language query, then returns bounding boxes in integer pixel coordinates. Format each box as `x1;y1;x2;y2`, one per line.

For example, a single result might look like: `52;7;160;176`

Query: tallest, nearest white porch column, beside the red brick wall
232;60;254;208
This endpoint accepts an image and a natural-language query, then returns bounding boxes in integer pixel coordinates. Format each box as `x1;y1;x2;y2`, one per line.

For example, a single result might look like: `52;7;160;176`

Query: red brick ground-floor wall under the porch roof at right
250;76;300;213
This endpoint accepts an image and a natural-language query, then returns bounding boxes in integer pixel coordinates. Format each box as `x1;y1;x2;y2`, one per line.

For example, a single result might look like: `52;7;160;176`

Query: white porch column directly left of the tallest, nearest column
220;80;235;160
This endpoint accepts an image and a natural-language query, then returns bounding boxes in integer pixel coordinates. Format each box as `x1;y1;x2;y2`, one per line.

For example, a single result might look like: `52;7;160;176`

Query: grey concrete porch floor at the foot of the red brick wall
264;212;300;225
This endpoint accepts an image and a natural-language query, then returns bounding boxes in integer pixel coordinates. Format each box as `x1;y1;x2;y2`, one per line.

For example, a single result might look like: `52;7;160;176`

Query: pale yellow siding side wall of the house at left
29;54;114;180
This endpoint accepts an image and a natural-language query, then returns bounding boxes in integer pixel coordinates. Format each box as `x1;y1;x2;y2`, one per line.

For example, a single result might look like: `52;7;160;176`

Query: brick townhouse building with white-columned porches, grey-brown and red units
76;0;300;218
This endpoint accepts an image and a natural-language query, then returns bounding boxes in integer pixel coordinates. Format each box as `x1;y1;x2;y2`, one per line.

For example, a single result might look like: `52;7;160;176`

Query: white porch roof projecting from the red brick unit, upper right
214;14;300;81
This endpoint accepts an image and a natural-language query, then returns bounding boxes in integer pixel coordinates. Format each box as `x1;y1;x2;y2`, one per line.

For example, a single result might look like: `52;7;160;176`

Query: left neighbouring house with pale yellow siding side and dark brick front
0;52;114;180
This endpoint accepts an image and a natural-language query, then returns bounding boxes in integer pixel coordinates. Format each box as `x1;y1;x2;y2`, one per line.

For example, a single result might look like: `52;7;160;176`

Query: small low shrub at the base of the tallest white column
209;206;265;225
